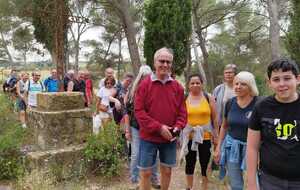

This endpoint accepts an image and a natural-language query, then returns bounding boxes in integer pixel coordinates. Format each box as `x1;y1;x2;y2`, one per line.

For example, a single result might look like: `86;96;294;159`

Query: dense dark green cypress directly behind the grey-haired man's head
144;0;192;74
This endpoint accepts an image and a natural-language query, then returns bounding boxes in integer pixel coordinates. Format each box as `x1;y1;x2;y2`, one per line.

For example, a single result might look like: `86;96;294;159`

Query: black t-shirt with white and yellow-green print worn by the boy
249;96;300;181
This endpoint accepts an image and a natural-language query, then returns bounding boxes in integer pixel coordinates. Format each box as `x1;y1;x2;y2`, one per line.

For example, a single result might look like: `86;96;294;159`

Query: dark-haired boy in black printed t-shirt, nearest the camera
247;59;300;190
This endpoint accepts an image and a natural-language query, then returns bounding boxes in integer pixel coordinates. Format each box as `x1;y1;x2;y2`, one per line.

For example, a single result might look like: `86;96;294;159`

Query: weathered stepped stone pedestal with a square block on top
27;92;92;178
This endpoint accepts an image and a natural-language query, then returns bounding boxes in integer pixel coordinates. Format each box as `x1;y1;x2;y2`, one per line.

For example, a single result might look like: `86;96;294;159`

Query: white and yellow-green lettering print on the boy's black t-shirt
274;119;299;141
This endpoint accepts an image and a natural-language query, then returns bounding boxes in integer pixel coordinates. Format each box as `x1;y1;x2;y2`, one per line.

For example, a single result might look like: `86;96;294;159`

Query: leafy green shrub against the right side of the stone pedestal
84;122;125;177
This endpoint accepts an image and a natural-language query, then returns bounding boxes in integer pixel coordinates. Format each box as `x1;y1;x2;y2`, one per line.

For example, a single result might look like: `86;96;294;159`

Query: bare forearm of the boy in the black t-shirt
246;128;261;190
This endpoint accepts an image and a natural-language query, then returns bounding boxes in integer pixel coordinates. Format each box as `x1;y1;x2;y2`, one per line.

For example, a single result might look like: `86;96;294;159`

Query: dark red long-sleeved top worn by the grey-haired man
134;76;187;143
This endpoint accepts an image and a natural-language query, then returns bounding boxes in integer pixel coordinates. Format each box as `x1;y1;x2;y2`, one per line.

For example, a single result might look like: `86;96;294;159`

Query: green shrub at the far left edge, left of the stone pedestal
0;94;24;179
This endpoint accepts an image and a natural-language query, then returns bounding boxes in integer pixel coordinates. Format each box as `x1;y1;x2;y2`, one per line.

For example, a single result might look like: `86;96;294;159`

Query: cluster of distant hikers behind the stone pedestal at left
3;69;93;128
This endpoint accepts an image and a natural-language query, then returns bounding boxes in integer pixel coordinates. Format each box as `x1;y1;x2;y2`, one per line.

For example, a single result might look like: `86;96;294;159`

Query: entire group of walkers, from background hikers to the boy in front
2;48;300;190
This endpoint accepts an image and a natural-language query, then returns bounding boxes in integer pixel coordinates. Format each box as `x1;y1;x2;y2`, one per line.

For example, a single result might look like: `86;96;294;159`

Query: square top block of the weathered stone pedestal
37;92;84;111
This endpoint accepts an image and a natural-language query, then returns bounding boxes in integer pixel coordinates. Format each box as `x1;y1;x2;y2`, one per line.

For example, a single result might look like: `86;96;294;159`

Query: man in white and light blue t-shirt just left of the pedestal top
24;71;45;108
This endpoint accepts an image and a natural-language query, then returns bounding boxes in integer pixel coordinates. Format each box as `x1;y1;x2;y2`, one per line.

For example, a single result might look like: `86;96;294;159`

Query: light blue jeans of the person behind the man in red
130;127;159;183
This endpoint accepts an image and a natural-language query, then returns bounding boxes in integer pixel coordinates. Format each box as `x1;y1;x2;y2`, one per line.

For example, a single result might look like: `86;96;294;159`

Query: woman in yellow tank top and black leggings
181;74;218;190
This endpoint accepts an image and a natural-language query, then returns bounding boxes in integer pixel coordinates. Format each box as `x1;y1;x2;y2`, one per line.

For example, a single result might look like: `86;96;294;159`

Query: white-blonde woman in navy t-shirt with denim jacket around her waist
214;71;259;190
